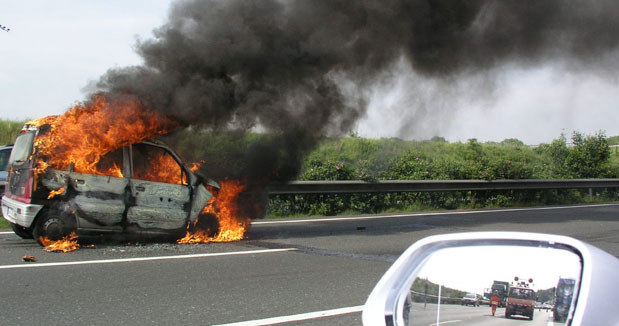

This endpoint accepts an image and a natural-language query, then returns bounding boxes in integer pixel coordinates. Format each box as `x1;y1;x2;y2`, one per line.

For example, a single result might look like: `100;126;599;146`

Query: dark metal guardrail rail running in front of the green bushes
267;179;619;195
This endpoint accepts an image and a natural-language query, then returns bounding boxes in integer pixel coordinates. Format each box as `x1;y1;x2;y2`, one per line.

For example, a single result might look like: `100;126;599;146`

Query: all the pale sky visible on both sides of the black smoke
0;0;619;145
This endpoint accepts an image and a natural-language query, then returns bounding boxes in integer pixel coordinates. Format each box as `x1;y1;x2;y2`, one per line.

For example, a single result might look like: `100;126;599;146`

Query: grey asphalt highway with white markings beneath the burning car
0;204;619;325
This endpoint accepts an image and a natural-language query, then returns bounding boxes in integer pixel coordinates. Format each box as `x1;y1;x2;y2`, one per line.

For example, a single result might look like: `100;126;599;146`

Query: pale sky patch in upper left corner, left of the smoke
0;0;171;120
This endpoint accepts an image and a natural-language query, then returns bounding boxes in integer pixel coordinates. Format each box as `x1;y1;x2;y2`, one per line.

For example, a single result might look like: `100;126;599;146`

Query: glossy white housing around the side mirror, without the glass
363;232;619;326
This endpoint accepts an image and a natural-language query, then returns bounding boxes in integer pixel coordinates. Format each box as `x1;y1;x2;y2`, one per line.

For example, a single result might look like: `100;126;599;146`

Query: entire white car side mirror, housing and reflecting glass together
363;232;619;326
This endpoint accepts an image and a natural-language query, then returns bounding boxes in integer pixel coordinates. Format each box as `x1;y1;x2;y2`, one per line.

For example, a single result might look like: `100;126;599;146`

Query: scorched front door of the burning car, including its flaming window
127;143;191;230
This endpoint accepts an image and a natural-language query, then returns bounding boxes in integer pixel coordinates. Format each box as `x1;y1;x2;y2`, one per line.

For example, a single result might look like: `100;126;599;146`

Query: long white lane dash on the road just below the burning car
0;248;297;269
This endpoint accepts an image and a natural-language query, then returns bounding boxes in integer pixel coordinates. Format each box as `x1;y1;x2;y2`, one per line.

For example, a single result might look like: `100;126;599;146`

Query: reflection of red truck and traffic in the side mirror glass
398;246;582;325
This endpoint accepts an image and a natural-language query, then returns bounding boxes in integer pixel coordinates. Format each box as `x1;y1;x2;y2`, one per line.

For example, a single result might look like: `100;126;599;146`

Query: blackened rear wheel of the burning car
32;210;75;245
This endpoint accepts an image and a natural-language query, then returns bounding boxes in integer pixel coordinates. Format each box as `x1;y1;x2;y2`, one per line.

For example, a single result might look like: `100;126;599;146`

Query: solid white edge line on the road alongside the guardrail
251;204;619;225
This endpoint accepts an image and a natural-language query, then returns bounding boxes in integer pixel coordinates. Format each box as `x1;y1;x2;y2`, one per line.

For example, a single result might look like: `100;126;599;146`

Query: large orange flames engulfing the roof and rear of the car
28;95;177;177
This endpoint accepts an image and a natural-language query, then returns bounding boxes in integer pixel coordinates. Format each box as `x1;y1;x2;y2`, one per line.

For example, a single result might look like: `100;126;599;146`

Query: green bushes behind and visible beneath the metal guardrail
269;133;619;216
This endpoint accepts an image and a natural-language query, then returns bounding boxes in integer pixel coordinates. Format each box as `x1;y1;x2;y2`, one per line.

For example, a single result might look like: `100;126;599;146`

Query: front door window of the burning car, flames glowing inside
133;144;186;184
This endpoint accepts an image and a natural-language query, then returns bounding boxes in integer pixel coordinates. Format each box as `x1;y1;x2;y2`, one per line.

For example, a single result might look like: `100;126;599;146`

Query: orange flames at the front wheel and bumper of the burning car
177;181;250;244
